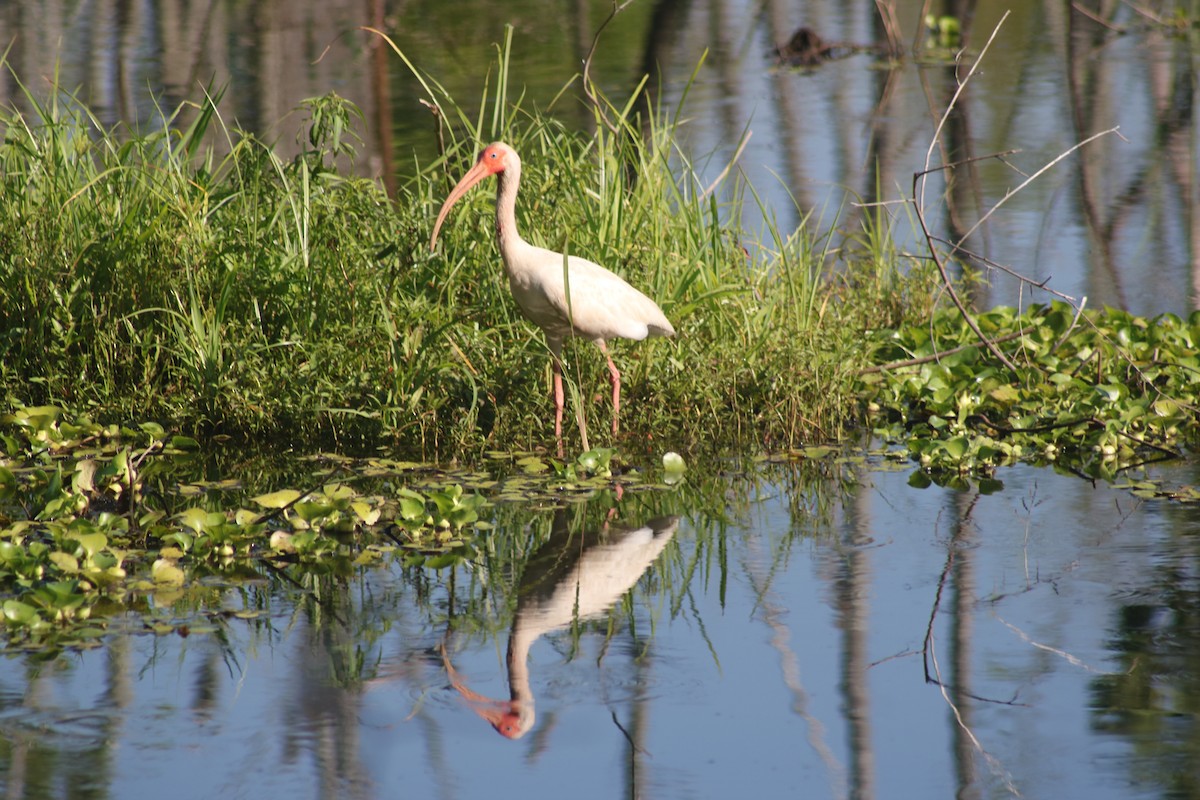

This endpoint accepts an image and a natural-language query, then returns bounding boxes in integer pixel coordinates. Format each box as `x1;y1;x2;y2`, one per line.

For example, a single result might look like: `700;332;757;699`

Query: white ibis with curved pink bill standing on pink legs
430;142;674;457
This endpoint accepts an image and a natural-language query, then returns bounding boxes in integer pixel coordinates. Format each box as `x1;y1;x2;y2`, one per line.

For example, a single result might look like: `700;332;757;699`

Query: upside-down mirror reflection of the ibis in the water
442;511;679;739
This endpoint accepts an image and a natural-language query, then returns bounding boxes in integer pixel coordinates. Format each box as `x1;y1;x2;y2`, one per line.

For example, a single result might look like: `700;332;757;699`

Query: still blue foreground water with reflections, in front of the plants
0;455;1200;799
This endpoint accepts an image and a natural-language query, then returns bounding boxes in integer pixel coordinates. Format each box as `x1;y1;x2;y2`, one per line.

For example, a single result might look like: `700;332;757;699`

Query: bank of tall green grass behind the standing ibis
0;42;928;458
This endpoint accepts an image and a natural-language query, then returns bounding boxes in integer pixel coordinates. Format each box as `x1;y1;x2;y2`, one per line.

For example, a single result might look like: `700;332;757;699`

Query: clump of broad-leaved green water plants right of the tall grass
863;302;1200;482
